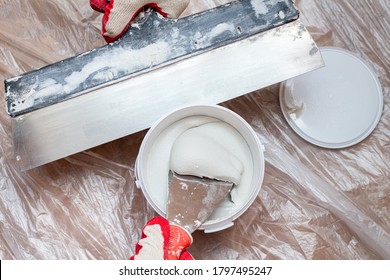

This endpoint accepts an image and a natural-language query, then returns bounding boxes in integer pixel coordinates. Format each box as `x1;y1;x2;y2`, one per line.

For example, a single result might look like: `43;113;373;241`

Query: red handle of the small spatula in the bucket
167;224;192;260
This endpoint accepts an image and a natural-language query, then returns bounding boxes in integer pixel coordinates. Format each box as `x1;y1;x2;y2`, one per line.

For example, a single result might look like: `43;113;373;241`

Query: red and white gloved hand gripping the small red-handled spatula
130;217;194;260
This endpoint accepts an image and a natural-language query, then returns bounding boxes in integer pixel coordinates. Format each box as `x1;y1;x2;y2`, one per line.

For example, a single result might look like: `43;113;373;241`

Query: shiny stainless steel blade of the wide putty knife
12;19;323;170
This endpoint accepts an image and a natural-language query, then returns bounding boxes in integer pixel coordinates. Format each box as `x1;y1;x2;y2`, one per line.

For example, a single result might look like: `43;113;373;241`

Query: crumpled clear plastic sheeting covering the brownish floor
0;0;390;259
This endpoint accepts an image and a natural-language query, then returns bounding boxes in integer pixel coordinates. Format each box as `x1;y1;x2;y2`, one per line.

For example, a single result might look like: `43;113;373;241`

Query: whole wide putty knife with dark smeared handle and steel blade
5;0;323;170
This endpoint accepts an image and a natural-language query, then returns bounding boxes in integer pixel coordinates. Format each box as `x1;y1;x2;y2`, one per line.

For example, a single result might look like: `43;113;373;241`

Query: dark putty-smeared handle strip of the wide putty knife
5;0;299;117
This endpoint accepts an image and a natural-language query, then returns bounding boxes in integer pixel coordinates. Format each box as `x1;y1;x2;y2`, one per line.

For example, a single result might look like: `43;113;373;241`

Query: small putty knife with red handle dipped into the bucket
167;172;234;260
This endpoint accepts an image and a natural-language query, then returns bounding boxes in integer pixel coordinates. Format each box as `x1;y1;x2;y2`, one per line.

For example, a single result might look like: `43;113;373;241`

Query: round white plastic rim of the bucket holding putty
135;105;264;232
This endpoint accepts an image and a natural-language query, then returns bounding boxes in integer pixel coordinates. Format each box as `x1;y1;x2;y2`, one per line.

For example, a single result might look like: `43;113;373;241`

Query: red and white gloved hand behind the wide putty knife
90;0;190;43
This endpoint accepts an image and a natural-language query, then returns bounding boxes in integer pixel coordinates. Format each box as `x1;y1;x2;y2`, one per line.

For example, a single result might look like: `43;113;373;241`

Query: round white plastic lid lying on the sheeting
279;47;383;149
